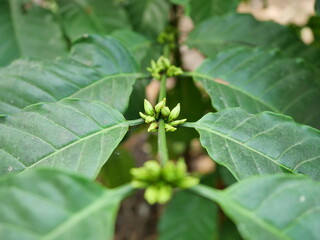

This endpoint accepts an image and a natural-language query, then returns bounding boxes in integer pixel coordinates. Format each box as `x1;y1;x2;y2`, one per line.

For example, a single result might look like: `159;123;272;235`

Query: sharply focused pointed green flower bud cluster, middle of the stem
139;98;187;132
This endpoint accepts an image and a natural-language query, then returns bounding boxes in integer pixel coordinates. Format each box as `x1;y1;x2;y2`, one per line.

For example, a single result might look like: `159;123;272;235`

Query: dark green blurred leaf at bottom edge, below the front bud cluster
159;191;218;240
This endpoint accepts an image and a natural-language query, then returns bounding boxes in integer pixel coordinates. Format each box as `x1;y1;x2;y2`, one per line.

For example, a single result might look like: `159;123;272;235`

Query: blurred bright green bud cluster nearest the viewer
130;159;199;204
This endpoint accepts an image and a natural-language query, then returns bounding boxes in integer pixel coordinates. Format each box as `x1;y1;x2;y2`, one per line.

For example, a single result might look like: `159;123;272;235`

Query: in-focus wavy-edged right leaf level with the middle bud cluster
187;108;320;180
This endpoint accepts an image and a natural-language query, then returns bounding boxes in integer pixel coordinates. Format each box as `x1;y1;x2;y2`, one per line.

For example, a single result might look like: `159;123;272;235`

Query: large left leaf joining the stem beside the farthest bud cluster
0;35;141;114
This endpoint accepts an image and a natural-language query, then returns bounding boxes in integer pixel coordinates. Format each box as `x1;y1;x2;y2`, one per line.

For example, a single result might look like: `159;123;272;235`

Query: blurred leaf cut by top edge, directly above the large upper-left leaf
58;0;130;39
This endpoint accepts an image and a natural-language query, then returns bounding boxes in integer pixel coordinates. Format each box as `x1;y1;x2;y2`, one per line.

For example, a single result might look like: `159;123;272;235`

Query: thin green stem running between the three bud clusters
158;74;169;165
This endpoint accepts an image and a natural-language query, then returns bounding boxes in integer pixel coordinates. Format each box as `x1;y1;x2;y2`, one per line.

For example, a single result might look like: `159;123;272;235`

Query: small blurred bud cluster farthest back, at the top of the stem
147;56;183;80
